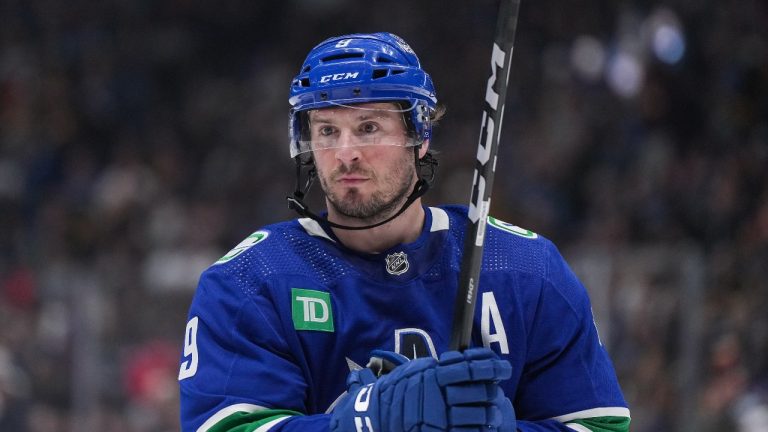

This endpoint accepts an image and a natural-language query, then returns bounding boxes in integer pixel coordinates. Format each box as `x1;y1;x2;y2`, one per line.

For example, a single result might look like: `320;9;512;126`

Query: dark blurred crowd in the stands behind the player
0;0;768;432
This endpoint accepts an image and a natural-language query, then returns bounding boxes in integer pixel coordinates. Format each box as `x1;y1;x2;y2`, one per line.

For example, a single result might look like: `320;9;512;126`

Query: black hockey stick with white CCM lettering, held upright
450;0;520;351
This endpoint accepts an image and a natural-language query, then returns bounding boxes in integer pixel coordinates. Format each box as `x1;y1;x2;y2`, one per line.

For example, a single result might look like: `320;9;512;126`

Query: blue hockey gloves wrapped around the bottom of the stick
330;348;515;432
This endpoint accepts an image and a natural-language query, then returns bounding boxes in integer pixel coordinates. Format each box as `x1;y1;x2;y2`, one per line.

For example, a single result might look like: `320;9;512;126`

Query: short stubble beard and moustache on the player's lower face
318;157;415;223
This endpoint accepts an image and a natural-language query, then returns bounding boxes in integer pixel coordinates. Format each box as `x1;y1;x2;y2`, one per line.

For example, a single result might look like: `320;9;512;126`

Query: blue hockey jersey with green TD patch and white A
179;206;629;432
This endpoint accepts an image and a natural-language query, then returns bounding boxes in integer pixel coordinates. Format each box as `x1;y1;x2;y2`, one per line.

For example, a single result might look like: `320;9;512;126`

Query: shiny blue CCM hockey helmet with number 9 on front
288;33;437;157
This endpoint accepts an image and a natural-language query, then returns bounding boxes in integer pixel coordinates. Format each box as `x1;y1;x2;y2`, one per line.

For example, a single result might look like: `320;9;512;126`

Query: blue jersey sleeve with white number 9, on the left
179;266;328;431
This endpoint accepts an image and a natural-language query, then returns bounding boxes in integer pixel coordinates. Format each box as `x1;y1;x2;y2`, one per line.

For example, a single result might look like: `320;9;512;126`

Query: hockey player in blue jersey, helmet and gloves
179;33;629;432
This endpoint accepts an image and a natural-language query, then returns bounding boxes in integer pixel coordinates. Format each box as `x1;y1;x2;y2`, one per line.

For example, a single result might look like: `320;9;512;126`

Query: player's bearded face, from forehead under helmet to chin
309;103;416;220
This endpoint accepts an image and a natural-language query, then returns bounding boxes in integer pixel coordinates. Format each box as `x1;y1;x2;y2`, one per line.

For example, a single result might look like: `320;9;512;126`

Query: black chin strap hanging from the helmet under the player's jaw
285;147;437;231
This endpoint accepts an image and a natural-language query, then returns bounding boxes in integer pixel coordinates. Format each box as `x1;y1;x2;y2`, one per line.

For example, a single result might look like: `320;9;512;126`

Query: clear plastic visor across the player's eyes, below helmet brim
292;102;421;156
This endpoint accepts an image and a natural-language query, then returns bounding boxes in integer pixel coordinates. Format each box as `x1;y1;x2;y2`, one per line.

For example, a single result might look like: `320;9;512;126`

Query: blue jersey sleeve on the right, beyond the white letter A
513;243;629;431
